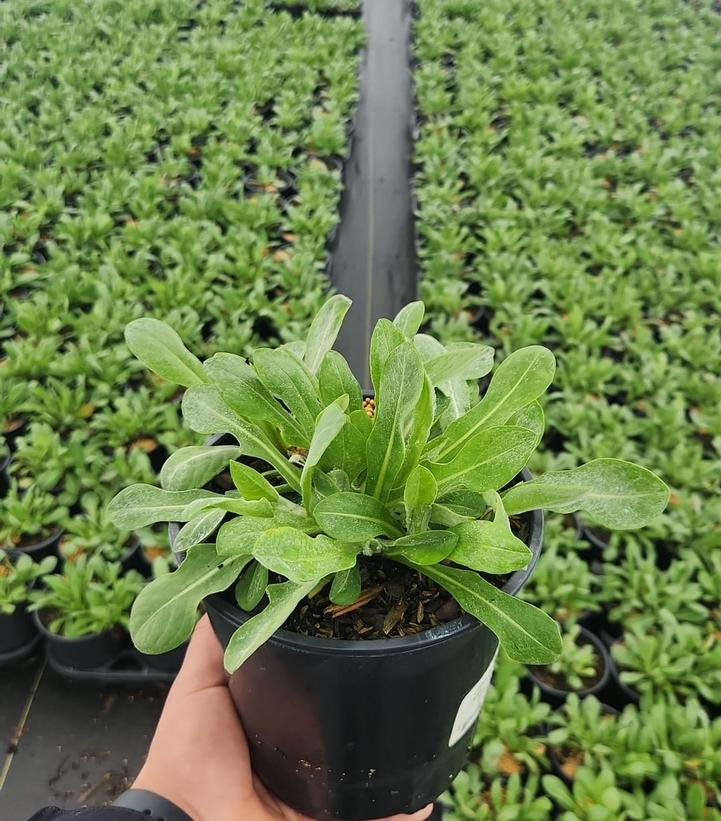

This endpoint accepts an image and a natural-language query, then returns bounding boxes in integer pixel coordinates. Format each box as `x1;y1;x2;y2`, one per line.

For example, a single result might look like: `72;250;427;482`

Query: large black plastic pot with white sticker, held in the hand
170;437;543;821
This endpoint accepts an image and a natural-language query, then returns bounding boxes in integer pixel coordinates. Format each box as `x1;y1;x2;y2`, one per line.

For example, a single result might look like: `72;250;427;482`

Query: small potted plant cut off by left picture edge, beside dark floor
0;550;57;656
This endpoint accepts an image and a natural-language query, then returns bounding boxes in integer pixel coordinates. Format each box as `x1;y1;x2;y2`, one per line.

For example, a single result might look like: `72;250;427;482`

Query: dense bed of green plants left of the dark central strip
0;0;364;542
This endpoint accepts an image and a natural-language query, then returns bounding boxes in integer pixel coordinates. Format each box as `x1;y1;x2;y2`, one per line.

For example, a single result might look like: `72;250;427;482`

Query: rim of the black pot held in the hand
173;434;543;657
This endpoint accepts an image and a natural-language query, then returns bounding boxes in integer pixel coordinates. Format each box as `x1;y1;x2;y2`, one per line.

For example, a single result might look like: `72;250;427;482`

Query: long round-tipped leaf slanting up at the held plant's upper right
428;345;556;459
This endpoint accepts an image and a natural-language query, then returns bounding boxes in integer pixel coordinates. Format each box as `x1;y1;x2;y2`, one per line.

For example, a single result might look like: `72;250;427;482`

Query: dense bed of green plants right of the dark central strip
414;0;721;819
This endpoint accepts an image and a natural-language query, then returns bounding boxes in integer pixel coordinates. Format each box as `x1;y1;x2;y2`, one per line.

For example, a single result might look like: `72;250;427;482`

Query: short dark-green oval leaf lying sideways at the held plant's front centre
313;493;403;542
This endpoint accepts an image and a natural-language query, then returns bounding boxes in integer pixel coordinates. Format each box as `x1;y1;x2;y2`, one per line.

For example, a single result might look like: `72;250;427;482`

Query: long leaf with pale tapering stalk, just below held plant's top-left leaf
183;385;300;491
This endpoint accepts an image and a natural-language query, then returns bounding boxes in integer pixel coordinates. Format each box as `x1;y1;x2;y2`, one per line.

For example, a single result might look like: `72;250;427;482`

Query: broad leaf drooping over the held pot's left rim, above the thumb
130;544;250;653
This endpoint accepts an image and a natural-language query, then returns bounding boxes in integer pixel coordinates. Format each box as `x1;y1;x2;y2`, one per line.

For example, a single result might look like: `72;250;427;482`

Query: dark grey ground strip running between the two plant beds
330;0;418;387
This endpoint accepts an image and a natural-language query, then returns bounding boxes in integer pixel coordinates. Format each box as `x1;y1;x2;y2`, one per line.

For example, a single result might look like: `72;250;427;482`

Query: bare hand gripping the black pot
133;616;432;821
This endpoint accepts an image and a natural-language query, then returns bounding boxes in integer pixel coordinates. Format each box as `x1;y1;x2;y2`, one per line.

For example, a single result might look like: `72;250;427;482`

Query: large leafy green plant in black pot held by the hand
111;296;668;821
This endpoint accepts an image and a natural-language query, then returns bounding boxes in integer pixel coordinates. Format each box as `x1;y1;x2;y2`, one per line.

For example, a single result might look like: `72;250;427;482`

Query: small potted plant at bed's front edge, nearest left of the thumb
28;556;145;670
